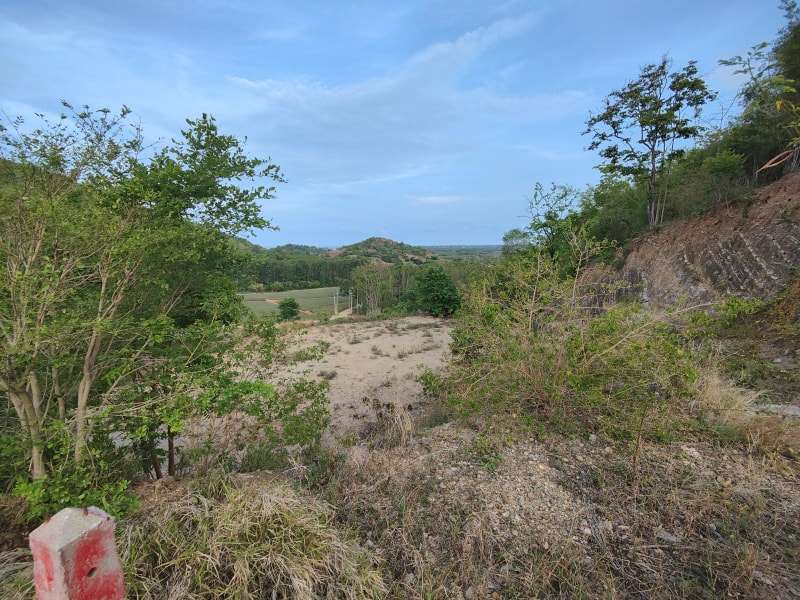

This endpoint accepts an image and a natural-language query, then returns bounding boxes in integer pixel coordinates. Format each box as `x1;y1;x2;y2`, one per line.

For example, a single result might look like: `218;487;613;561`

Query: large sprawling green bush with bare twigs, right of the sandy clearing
447;238;697;440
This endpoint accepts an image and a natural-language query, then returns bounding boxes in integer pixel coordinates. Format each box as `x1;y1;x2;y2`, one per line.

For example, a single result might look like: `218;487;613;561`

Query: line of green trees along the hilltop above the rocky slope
504;1;800;271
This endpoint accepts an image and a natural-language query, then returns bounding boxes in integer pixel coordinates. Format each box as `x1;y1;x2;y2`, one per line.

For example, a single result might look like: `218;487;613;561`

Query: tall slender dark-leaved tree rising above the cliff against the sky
584;58;716;227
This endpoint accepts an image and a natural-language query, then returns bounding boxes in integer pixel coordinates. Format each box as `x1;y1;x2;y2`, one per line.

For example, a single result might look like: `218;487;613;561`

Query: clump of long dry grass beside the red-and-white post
121;478;385;600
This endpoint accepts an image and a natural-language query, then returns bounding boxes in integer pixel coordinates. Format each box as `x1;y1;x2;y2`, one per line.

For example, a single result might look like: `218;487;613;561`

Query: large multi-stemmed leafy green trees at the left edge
0;103;282;478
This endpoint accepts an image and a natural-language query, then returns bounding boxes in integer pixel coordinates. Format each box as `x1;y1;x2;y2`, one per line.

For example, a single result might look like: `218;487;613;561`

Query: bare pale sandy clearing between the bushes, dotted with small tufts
290;317;450;436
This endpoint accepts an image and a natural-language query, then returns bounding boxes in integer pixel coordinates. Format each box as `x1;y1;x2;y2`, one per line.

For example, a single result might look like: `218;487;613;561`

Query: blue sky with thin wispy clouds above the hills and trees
0;0;782;246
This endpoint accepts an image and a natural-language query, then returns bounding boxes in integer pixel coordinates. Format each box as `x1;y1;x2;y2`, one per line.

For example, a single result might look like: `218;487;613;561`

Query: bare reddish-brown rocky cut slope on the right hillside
623;173;800;304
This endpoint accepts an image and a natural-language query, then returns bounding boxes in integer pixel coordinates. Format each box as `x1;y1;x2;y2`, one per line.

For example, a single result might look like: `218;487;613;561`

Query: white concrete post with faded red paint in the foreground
29;506;125;600
